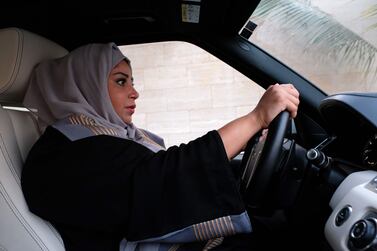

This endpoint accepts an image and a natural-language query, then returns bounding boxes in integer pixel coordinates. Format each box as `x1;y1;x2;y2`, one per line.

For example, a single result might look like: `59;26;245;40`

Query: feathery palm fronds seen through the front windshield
251;0;377;78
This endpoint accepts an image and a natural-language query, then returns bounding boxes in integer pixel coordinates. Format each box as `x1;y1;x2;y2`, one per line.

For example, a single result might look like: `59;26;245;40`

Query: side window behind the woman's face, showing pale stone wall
120;42;264;146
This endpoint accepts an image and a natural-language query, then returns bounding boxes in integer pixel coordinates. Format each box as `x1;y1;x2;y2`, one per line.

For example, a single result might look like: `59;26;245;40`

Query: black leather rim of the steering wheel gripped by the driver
241;111;289;209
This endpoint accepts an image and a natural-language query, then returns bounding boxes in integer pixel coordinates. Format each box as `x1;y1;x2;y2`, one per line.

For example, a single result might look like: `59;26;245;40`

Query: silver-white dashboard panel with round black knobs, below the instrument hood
325;171;377;251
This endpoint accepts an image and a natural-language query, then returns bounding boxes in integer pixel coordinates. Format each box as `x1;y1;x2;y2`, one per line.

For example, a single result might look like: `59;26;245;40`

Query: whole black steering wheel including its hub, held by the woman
241;111;290;209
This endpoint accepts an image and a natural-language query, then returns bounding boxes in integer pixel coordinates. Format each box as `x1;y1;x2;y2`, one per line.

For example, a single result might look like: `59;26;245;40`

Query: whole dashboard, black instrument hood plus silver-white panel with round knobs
319;93;377;251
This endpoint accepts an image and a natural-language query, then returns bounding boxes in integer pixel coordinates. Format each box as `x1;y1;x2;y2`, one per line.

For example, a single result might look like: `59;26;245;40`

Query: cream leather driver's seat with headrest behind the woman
0;28;67;251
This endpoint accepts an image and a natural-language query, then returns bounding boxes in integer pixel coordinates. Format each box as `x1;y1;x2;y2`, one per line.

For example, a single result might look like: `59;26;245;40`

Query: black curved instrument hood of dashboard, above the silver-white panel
319;93;377;170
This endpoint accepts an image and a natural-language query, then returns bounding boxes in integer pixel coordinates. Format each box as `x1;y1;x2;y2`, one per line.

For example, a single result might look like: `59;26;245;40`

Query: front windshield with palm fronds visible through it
249;0;377;94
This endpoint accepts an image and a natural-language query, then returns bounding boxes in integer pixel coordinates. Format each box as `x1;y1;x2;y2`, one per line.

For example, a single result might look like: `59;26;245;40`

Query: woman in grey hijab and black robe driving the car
22;43;299;250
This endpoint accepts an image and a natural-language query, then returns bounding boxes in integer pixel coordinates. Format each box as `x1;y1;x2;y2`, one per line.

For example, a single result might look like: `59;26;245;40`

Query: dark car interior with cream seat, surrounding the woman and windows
0;0;377;251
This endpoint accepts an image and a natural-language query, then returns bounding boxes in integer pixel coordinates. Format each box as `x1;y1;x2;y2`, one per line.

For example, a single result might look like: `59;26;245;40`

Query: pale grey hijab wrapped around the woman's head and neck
23;43;164;152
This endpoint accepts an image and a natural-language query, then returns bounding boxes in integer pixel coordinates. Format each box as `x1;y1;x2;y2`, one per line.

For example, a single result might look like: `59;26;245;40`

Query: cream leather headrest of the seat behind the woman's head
0;27;68;104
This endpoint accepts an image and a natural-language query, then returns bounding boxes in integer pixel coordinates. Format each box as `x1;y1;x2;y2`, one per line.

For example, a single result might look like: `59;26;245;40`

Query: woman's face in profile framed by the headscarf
108;60;139;124
